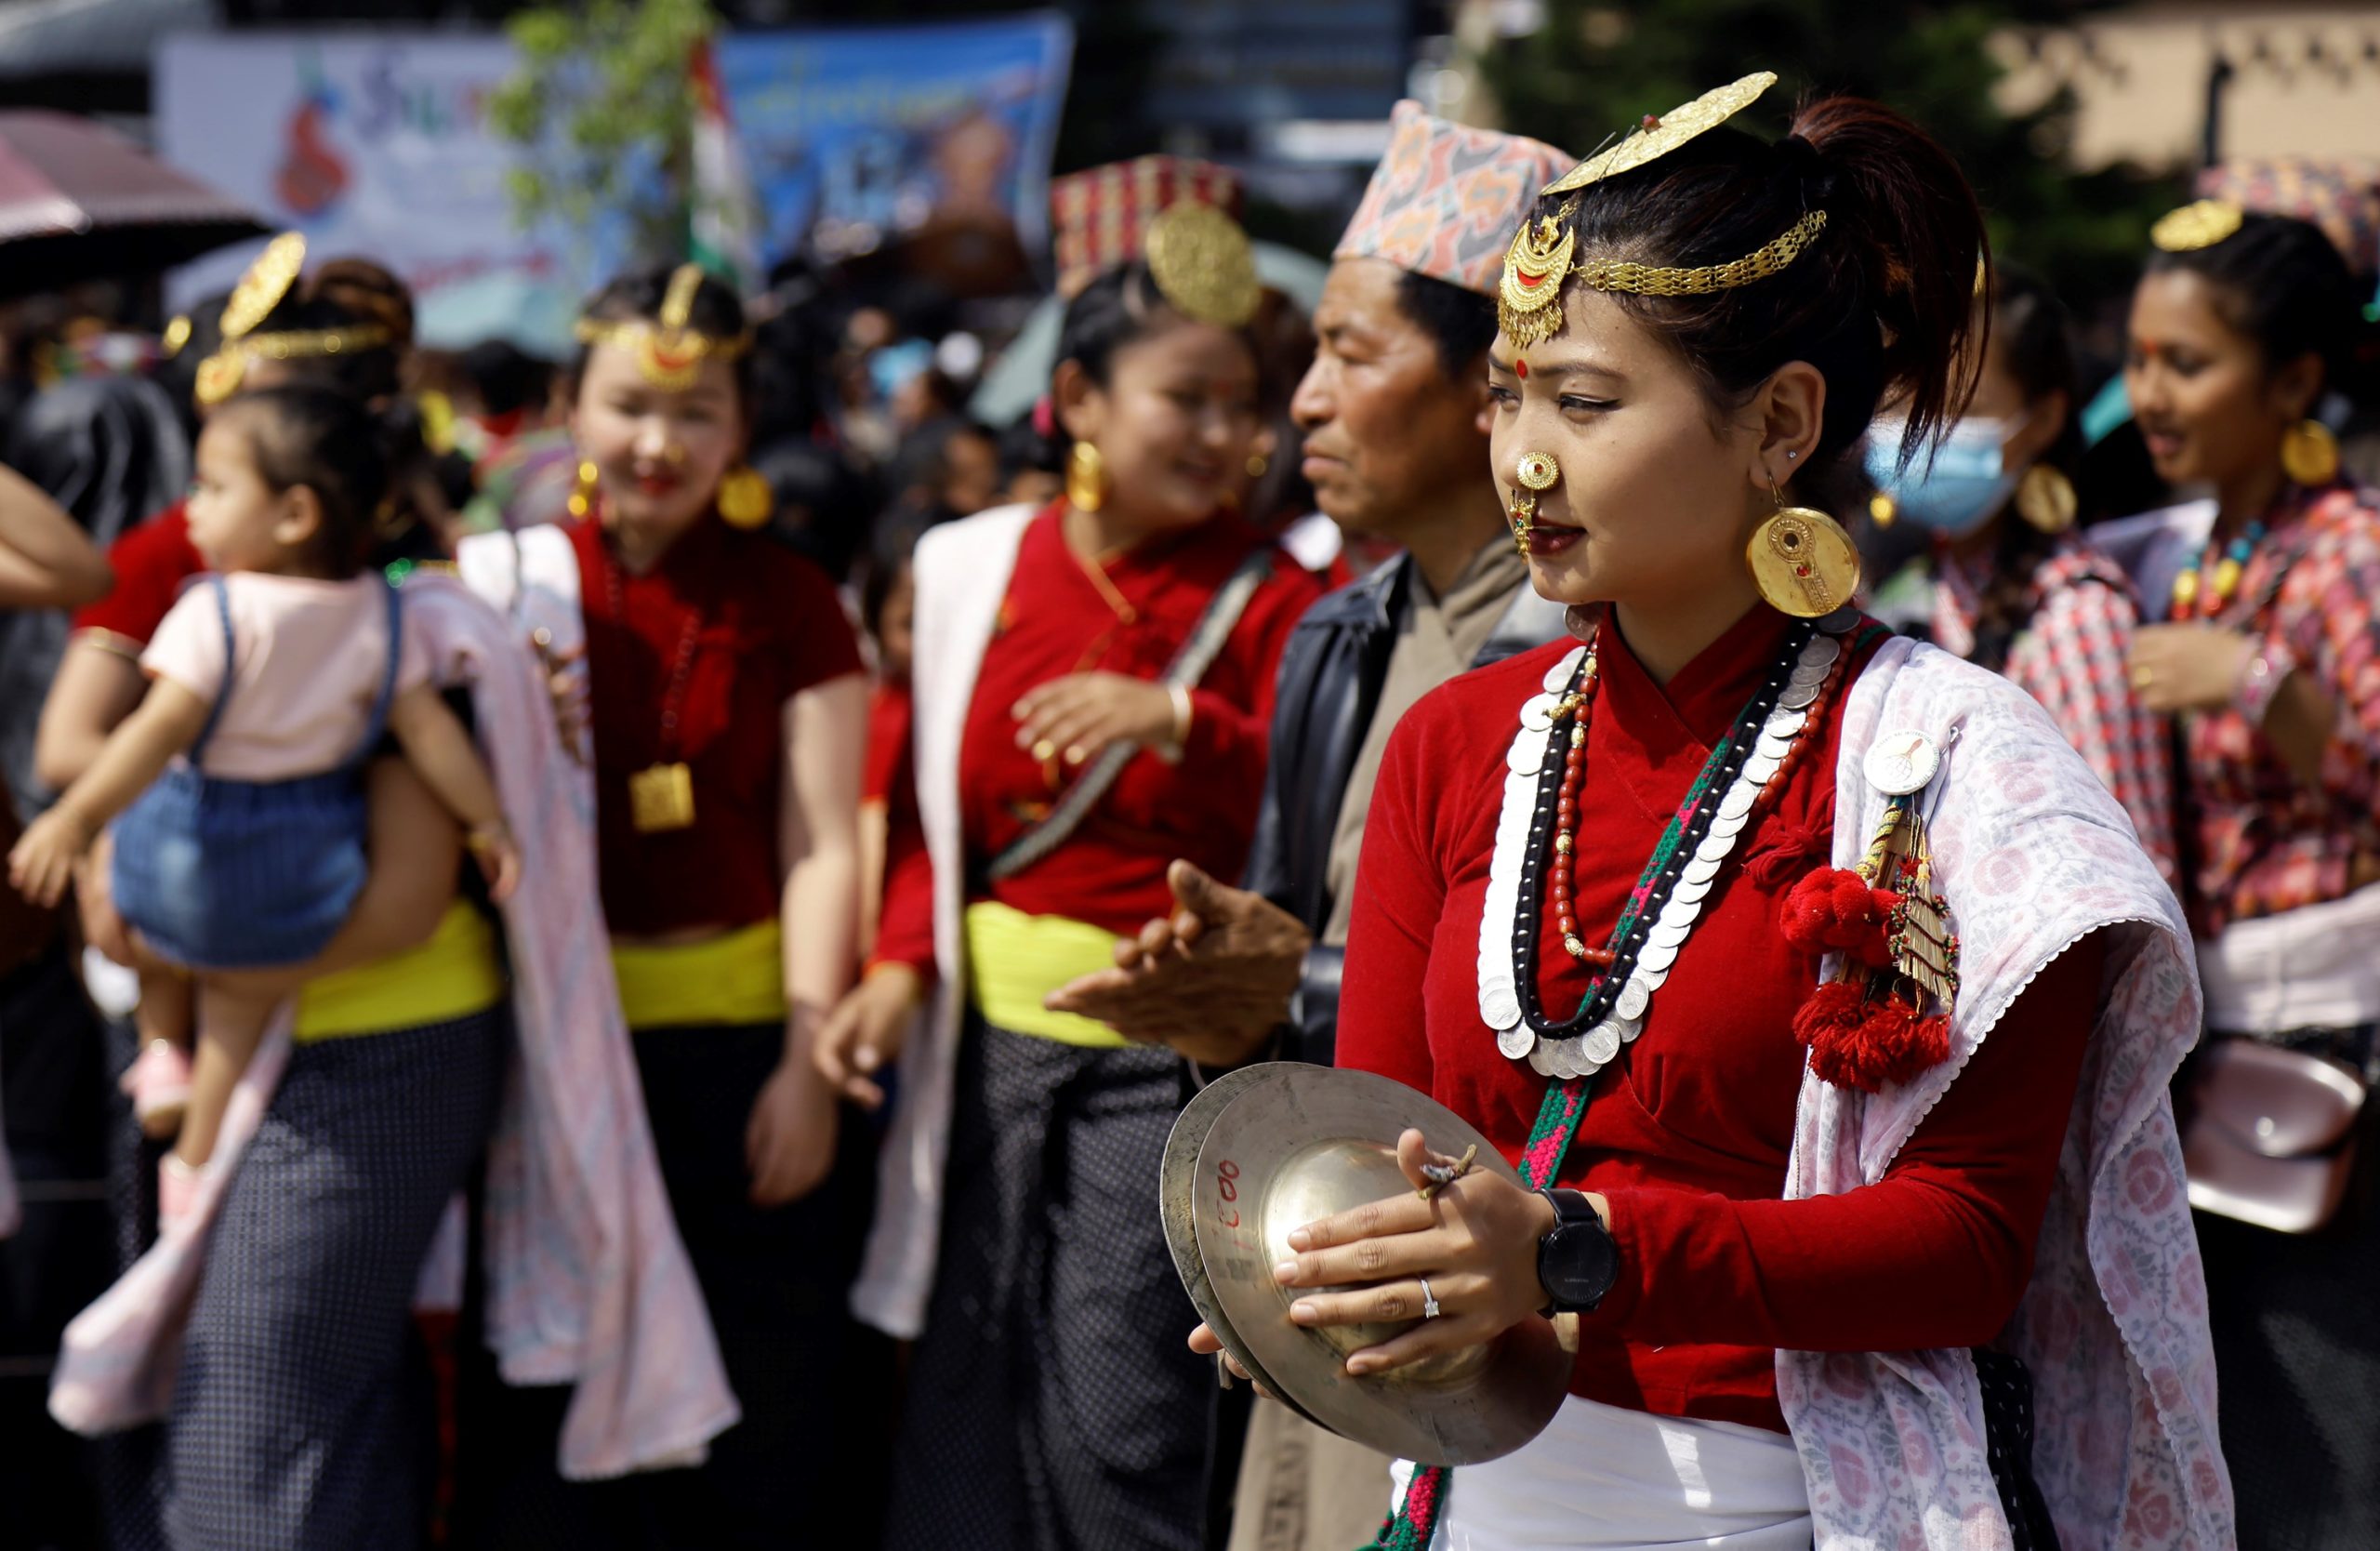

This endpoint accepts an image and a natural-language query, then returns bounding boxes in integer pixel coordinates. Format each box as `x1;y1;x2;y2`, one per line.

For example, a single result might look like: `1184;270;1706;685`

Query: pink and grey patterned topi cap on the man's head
1330;102;1578;298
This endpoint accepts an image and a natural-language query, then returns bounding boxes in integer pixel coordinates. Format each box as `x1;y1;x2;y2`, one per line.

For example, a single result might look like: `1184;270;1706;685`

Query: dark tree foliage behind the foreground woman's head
1483;0;2180;314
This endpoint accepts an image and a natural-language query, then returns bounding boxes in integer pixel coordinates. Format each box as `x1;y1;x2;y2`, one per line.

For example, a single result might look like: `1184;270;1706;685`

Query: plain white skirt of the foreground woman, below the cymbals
1395;1394;1811;1551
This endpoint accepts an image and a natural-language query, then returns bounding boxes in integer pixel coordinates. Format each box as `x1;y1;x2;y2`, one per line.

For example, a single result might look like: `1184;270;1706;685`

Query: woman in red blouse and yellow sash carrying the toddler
35;247;509;1546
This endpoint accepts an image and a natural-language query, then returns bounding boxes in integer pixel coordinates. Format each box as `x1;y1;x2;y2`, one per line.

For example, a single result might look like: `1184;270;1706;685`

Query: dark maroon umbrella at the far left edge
0;112;269;295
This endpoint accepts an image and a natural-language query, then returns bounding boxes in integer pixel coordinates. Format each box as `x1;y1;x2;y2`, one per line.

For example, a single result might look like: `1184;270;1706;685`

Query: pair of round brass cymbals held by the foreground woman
1157;1061;1571;1465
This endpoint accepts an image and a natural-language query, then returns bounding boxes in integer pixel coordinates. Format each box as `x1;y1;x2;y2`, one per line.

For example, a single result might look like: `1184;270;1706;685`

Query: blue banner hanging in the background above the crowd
719;14;1074;259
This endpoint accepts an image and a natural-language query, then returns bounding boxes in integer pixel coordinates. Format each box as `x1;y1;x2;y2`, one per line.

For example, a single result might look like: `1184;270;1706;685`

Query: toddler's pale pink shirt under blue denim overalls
140;571;430;780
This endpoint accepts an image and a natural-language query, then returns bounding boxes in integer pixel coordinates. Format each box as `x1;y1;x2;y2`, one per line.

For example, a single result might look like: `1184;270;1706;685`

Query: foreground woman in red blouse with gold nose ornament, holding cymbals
1193;76;2220;1551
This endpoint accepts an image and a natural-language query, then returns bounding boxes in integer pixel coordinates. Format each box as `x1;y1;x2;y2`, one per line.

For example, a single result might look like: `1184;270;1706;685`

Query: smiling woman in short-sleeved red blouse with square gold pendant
459;264;890;1548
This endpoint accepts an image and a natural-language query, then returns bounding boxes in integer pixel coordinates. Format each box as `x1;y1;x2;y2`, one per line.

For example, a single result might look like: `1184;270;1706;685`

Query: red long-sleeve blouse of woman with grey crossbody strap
876;502;1321;973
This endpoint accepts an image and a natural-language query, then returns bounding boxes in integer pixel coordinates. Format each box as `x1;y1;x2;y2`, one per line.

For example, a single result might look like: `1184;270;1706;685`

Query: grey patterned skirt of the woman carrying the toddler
166;1011;509;1551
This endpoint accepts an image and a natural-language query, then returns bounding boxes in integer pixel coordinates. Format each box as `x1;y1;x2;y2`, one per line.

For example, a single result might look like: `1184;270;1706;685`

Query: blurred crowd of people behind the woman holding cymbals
0;78;2380;1551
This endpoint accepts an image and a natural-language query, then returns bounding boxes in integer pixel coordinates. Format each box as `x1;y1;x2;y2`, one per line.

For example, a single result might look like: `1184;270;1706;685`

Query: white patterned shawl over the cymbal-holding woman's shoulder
1778;640;2232;1551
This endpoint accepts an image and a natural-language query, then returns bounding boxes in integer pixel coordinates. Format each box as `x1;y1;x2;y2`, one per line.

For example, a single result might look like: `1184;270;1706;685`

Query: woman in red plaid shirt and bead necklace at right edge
2125;202;2380;1548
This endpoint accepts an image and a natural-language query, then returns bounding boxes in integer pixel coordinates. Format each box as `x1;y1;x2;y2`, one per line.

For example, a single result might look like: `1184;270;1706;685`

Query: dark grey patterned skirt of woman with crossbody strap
885;1018;1214;1551
